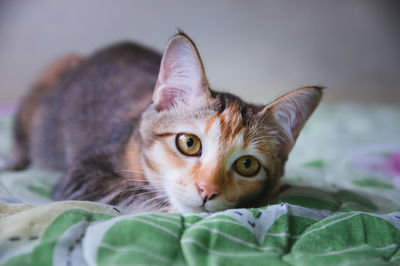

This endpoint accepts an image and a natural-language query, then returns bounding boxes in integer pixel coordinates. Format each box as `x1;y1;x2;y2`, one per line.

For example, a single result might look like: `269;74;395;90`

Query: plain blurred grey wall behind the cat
0;0;400;103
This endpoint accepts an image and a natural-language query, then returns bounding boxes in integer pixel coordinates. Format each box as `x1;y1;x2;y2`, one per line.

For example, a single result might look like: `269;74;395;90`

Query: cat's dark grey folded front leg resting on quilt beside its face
52;147;164;213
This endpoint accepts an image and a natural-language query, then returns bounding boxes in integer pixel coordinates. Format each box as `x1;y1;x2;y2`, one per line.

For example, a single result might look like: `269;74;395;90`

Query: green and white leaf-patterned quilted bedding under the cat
0;104;400;265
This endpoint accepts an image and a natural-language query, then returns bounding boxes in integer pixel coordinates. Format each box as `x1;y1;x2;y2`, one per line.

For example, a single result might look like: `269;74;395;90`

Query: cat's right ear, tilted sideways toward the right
262;87;323;153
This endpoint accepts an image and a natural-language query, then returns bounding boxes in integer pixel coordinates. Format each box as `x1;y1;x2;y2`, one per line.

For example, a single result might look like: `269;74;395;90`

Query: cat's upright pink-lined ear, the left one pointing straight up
153;34;211;111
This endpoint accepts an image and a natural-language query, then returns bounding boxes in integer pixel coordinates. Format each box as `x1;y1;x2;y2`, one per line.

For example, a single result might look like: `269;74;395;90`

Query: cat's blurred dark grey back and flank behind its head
32;42;161;168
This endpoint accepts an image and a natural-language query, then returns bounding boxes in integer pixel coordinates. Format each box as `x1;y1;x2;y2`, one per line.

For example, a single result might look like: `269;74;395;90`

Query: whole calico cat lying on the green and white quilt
3;32;322;213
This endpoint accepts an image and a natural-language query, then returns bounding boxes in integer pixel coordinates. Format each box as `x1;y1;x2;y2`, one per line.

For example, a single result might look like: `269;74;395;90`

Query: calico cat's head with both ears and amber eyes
140;34;322;213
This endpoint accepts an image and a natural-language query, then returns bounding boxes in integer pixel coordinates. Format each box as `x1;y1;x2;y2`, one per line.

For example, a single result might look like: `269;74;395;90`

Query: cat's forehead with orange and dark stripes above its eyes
153;93;276;143
